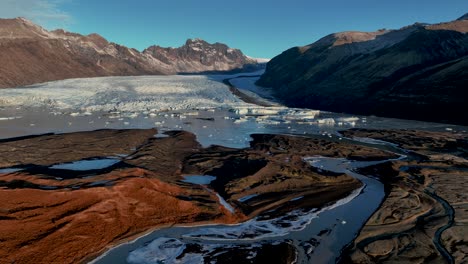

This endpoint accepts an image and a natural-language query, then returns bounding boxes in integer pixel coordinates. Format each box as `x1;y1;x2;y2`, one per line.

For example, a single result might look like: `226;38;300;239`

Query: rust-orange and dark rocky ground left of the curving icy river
0;129;394;263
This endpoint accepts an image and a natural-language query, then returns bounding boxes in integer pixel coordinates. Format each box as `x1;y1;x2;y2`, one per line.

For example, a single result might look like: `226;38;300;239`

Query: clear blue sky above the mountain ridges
0;0;468;58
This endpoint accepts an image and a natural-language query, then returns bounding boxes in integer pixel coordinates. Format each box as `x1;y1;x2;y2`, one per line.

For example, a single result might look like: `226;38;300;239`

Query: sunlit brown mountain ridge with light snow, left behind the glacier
0;18;258;87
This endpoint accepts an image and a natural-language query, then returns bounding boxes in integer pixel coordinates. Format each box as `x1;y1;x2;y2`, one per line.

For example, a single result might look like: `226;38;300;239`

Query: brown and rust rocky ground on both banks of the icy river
0;129;468;263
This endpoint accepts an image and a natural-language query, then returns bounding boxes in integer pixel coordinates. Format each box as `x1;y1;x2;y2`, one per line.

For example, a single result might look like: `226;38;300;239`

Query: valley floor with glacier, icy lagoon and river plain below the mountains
0;73;467;263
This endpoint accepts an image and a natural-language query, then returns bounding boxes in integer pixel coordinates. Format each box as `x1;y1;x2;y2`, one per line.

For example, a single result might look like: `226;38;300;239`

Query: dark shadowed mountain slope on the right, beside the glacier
257;14;468;125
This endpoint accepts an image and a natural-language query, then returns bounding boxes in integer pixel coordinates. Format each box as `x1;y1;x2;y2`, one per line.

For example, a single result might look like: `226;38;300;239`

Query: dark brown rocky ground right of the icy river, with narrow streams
342;129;468;263
